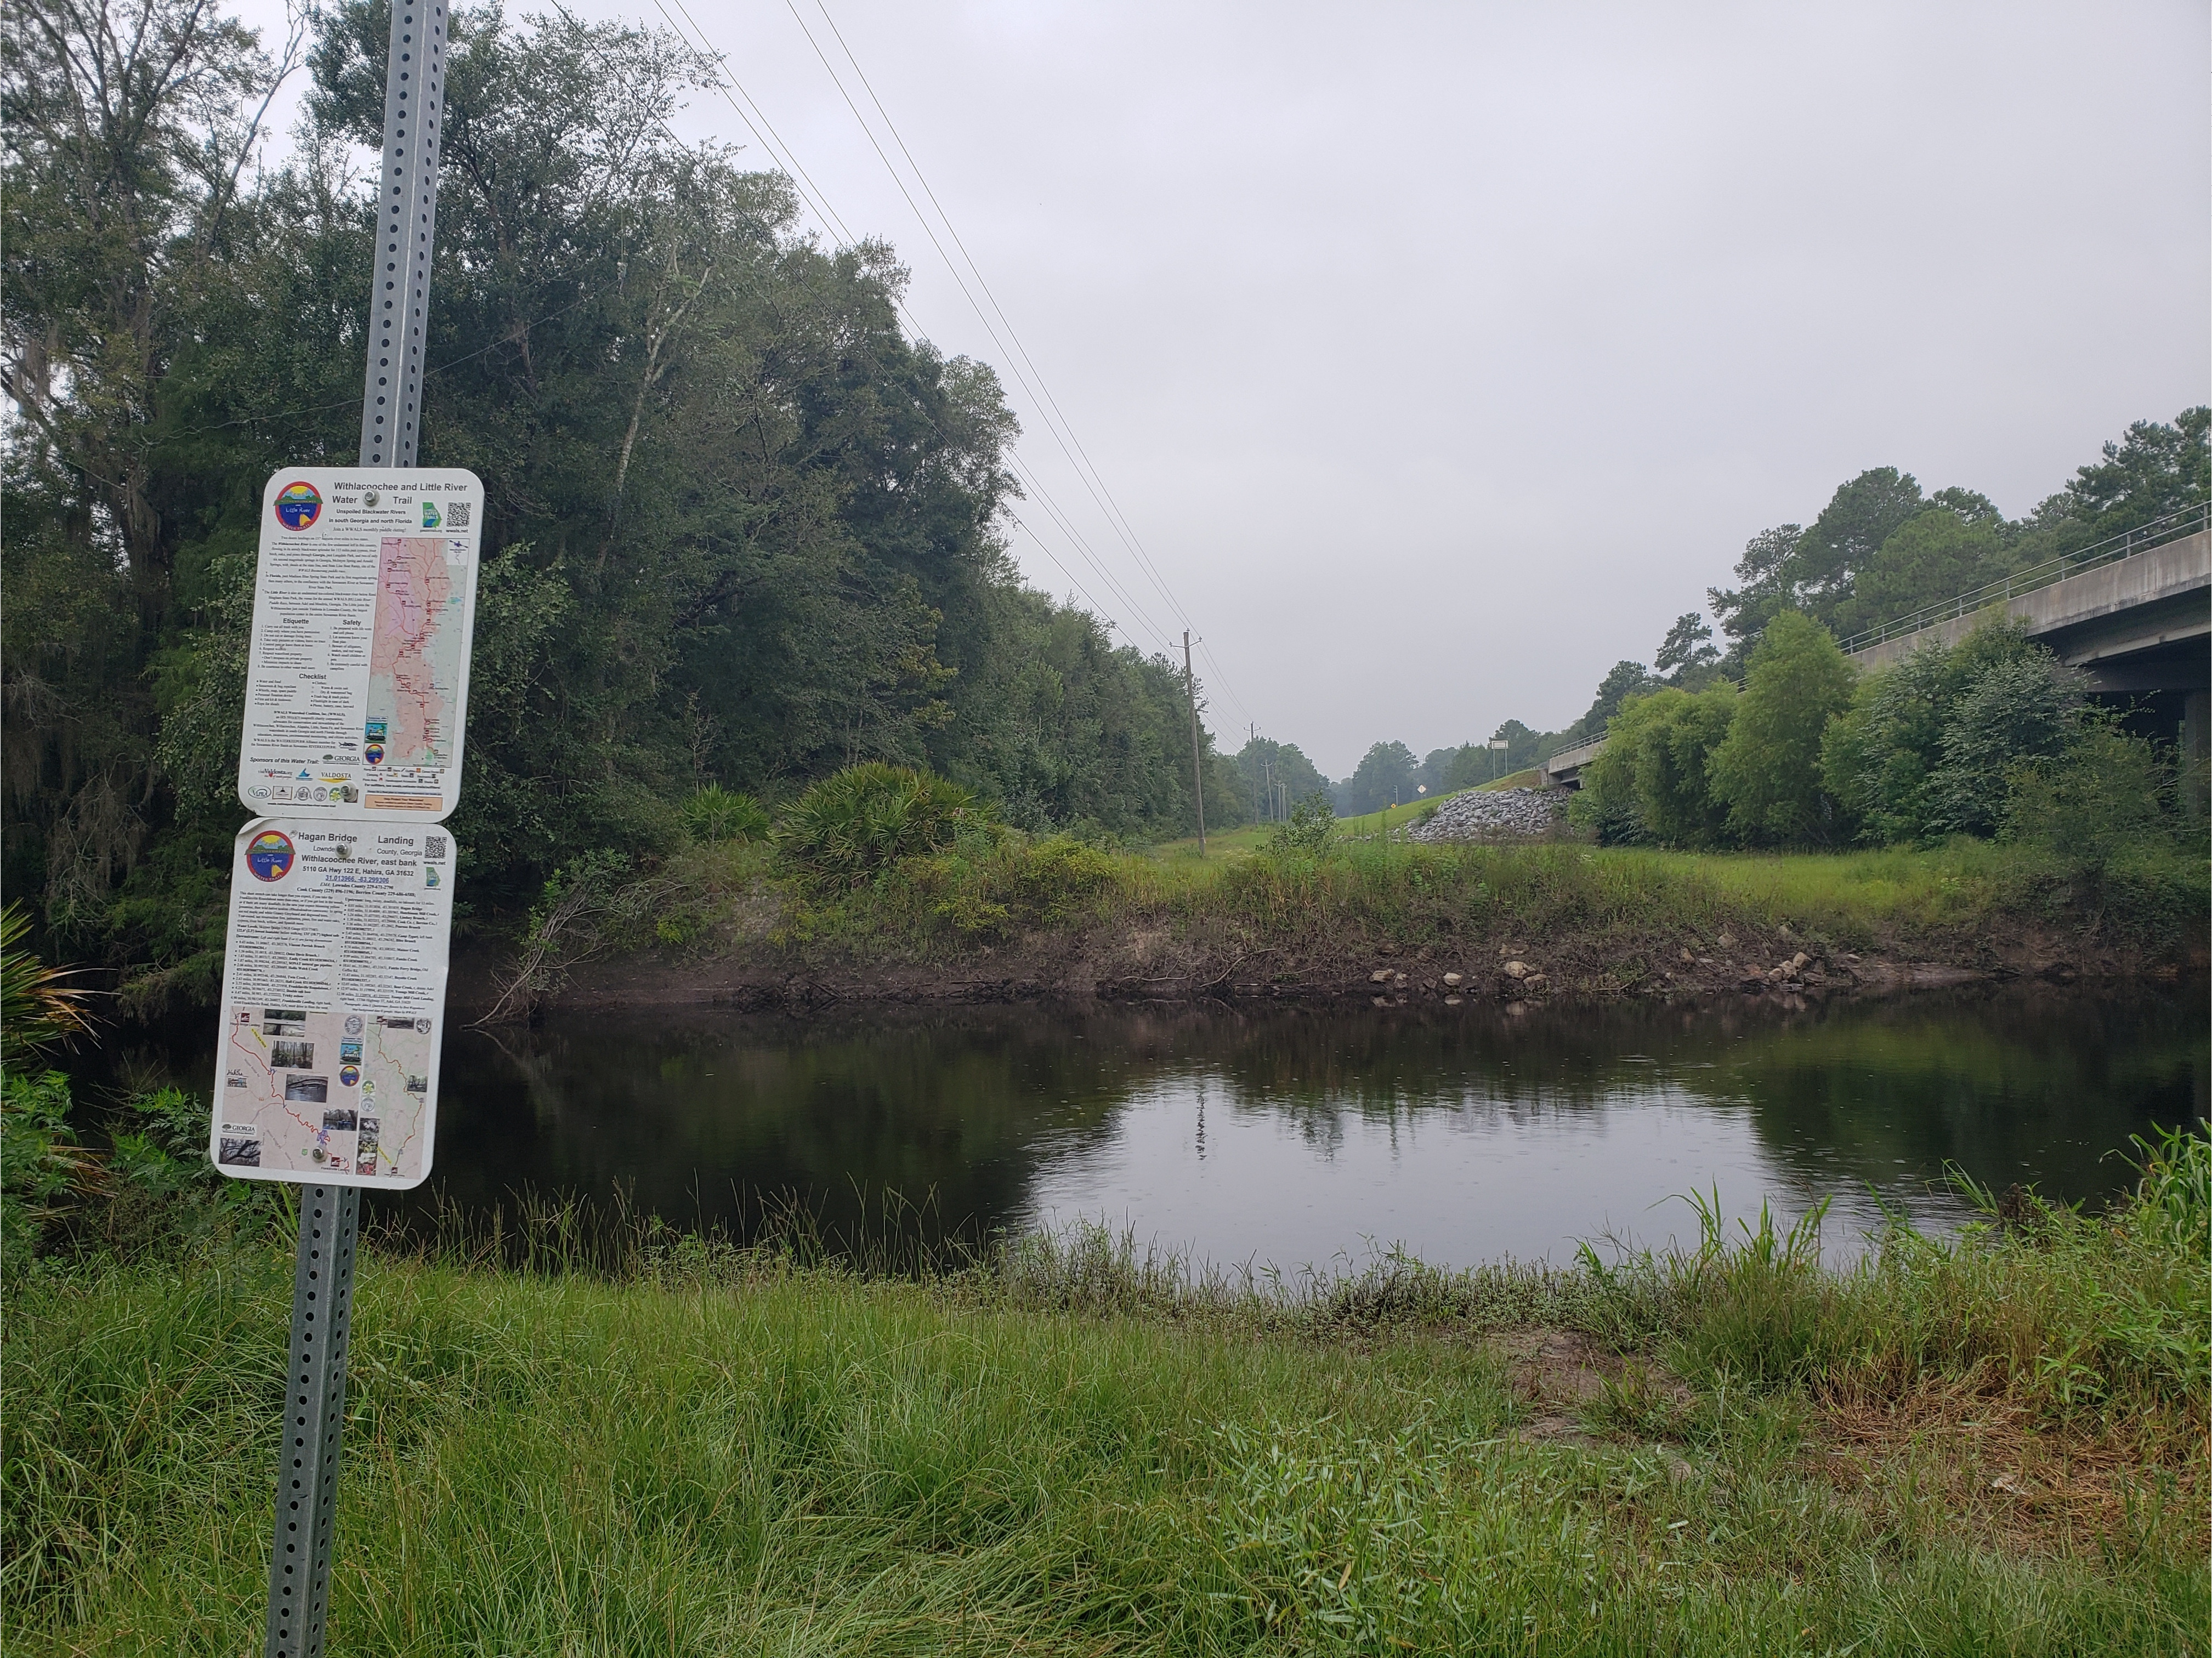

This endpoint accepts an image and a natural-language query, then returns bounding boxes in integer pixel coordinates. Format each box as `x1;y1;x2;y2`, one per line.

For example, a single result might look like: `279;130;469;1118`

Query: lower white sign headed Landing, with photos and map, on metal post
208;818;453;1189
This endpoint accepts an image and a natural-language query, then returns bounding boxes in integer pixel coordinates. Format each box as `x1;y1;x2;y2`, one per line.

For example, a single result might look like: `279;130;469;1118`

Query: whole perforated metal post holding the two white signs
258;0;447;1658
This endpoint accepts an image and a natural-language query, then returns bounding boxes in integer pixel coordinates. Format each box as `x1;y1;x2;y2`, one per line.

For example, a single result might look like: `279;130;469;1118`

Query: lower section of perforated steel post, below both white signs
263;1185;361;1658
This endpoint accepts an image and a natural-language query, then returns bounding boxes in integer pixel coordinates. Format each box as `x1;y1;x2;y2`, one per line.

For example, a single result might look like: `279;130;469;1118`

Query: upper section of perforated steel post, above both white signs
361;0;445;467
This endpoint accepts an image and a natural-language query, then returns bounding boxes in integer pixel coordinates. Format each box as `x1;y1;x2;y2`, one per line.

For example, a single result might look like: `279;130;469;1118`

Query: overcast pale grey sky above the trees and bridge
243;0;2212;776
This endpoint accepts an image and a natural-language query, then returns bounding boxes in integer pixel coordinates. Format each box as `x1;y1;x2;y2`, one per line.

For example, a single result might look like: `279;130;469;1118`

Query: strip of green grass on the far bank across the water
703;814;2212;992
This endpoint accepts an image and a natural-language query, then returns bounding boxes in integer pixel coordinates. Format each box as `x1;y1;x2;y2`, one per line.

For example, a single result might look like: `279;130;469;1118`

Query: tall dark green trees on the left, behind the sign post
0;0;1252;997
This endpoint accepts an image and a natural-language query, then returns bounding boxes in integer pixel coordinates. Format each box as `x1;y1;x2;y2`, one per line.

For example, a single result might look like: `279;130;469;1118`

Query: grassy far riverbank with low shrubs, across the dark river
575;838;2212;1012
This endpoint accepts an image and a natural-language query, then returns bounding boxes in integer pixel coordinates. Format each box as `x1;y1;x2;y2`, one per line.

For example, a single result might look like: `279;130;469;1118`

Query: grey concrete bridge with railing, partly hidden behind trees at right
1542;506;2212;789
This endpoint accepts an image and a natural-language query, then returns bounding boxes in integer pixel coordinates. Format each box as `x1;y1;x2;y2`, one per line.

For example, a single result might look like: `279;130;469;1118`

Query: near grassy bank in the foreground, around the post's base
0;1141;2212;1654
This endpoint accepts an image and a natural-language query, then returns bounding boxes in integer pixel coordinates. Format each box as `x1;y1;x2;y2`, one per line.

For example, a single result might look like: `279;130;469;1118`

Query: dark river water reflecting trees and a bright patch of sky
116;986;2208;1269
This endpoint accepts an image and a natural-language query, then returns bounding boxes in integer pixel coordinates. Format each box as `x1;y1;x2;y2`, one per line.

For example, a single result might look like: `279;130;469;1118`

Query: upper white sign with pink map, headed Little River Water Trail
239;467;484;822
